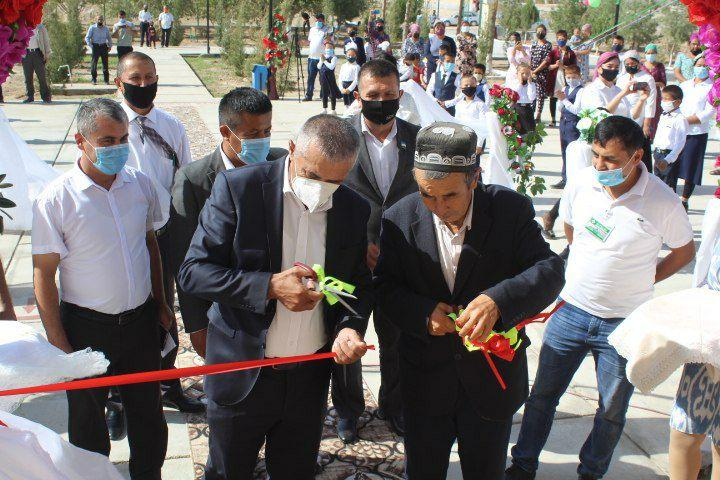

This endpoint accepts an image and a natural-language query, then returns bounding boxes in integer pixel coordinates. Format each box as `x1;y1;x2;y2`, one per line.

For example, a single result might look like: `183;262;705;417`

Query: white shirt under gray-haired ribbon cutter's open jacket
265;160;332;357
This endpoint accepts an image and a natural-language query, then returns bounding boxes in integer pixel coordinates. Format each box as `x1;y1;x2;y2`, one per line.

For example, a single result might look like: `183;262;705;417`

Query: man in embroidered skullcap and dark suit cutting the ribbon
374;123;564;480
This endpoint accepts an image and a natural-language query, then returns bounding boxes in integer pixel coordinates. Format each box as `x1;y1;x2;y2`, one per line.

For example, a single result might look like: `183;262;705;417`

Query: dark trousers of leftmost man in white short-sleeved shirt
60;300;168;480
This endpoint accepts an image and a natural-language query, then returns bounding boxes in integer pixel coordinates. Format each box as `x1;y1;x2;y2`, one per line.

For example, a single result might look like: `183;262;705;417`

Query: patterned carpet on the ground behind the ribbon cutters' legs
177;318;405;480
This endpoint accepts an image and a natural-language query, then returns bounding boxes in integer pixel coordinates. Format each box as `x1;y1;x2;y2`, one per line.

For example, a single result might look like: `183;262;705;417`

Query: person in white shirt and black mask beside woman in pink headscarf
617;50;657;172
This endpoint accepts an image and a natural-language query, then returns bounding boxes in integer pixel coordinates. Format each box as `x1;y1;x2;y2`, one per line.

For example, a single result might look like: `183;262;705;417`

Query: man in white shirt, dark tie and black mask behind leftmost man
115;52;203;412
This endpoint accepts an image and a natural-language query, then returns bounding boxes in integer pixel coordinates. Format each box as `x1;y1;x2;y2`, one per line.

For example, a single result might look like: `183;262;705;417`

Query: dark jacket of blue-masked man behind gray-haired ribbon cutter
166;146;287;333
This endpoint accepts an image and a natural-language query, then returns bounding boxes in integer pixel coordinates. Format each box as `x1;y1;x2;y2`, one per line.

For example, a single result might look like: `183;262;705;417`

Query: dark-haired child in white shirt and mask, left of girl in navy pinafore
653;85;689;183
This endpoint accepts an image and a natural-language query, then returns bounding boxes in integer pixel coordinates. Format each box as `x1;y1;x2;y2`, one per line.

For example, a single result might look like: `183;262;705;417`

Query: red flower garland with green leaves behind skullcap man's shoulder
490;84;547;195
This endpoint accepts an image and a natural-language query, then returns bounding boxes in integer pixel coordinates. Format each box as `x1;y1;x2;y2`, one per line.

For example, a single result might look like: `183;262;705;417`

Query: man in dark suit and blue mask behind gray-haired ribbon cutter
168;87;287;358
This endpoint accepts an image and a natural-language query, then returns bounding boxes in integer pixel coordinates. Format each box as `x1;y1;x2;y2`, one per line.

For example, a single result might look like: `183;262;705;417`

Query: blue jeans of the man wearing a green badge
512;304;634;478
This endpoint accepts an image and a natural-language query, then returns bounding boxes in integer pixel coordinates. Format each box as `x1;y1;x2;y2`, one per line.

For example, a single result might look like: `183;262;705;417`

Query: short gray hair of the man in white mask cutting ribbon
295;114;360;162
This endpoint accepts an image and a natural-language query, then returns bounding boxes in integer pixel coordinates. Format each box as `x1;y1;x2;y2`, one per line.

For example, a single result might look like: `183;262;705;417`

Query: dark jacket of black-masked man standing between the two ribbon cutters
345;115;420;243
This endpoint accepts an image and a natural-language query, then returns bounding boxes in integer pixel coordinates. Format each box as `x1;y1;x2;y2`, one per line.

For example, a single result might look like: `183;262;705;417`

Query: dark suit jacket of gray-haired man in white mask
177;160;373;405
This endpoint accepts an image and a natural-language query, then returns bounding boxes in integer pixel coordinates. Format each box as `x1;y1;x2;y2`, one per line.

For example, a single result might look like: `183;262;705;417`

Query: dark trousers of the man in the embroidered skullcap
404;383;512;480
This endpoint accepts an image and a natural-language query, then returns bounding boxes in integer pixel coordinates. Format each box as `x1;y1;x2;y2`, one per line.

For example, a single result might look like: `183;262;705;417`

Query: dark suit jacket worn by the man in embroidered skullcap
374;185;564;420
